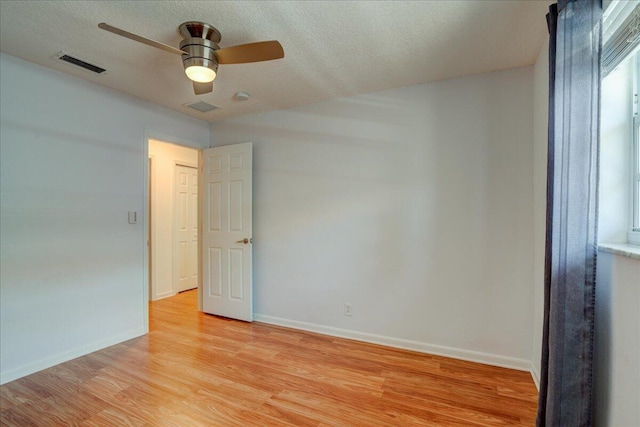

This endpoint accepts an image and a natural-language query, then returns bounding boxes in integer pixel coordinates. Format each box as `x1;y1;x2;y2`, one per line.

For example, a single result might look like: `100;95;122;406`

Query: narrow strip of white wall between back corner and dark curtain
531;40;549;386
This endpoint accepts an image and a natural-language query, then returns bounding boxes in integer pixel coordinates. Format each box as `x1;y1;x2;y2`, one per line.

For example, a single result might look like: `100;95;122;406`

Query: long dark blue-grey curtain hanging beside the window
536;0;602;427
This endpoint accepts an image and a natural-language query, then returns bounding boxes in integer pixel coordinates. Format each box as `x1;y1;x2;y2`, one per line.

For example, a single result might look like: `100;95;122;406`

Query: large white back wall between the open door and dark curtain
211;68;533;369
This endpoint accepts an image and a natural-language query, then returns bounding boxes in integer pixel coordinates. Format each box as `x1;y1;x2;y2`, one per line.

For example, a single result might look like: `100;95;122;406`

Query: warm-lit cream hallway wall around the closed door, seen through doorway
149;139;198;300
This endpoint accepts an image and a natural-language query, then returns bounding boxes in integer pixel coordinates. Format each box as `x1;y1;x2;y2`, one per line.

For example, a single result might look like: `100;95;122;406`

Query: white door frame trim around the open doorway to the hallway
141;129;209;333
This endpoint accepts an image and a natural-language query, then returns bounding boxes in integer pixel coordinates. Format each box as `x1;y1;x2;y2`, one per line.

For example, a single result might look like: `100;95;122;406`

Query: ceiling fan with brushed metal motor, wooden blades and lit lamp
98;21;284;95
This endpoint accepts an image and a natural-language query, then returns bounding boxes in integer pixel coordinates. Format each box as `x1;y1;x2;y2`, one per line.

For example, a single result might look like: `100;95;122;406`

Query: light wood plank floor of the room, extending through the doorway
0;291;537;427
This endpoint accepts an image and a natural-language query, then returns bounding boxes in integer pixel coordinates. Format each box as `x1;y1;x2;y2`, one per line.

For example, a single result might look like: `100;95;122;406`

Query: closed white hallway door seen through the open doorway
173;165;198;292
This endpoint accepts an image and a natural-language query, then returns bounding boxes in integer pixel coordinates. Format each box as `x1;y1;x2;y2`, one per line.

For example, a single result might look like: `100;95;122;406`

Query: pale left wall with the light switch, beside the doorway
0;54;209;382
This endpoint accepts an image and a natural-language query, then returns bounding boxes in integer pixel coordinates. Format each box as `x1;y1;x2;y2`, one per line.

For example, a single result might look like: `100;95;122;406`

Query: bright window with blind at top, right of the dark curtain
599;0;640;245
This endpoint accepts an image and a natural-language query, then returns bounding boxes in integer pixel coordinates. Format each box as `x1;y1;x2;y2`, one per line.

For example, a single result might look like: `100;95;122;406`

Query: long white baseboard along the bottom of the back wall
253;314;535;372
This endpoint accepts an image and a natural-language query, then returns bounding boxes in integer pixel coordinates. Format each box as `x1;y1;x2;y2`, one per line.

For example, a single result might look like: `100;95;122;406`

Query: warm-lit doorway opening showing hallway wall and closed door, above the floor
148;138;198;301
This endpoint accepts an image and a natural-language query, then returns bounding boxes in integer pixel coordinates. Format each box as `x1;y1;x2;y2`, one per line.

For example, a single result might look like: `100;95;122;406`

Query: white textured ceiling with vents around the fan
0;0;551;122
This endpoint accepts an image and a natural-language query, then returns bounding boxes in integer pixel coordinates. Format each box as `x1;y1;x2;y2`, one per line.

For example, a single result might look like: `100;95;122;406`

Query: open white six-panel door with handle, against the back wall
200;142;253;322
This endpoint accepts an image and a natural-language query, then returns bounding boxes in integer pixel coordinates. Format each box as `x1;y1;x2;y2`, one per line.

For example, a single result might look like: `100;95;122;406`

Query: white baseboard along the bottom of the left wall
0;328;146;385
